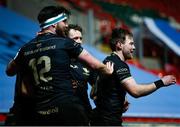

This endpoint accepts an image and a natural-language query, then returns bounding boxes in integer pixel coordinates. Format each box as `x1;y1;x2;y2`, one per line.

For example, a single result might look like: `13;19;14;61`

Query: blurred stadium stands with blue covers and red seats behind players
0;0;180;126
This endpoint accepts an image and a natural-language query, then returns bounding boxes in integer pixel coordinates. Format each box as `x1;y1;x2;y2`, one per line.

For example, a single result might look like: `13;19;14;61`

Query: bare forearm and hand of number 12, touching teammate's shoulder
78;49;113;74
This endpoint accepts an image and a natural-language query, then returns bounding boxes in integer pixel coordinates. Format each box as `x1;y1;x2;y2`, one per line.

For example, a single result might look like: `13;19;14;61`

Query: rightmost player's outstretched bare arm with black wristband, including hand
121;75;176;98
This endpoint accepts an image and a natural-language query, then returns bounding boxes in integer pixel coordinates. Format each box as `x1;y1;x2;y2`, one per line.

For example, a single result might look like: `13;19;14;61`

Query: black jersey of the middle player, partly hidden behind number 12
70;59;96;111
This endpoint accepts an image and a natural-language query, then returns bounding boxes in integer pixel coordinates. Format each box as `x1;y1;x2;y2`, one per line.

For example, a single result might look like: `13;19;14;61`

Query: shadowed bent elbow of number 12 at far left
6;59;17;76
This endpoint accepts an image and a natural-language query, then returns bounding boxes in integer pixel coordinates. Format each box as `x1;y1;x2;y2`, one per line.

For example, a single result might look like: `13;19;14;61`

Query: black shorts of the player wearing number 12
35;103;89;126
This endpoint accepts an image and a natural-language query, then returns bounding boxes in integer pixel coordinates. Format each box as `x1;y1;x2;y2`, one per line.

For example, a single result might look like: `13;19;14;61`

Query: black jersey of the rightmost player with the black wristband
96;53;131;116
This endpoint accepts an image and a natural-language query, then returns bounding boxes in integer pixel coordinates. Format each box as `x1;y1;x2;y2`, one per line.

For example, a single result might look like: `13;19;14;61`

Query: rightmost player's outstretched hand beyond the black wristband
161;75;176;86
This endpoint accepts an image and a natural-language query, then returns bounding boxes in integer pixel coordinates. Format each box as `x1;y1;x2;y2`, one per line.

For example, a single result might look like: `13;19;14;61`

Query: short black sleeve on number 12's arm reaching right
65;39;83;58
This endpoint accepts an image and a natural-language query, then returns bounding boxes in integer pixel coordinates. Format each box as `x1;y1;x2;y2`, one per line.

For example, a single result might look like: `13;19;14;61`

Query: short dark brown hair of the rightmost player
110;28;133;51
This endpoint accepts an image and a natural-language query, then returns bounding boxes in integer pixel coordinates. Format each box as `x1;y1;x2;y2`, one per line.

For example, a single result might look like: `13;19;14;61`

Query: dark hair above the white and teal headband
37;6;71;24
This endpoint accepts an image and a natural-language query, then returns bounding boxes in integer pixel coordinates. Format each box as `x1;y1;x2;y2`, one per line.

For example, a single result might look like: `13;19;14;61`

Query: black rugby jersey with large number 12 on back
15;33;83;110
